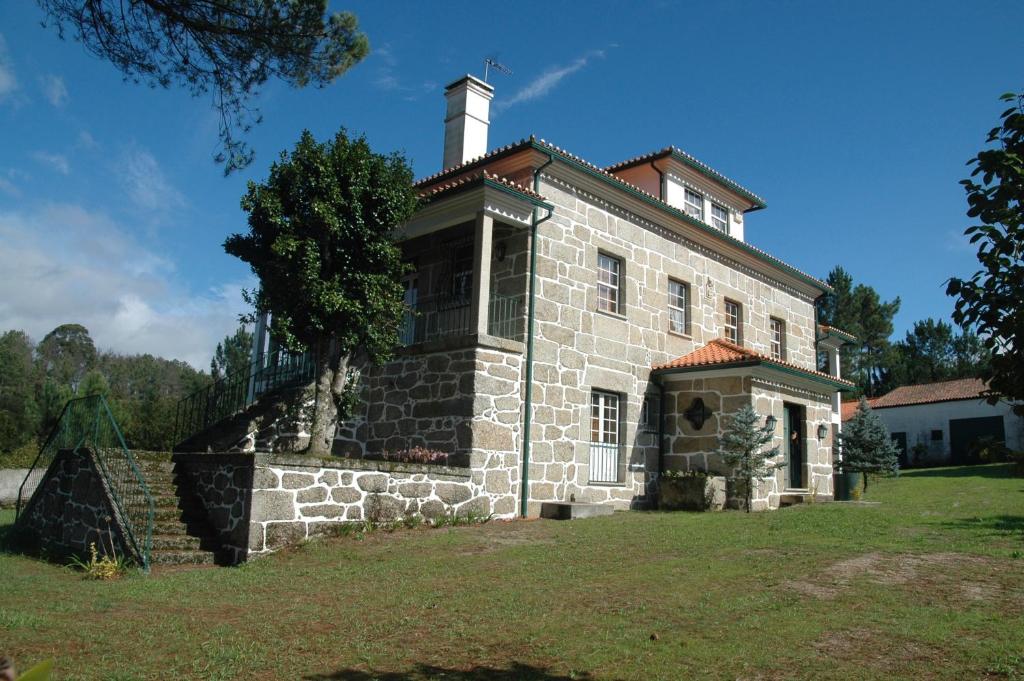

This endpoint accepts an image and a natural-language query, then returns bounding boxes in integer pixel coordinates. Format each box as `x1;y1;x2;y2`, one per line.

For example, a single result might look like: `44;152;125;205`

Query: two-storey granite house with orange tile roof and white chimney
249;76;850;517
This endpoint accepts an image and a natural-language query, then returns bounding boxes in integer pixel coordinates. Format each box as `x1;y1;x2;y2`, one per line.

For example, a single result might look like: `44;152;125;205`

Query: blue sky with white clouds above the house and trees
0;1;1024;367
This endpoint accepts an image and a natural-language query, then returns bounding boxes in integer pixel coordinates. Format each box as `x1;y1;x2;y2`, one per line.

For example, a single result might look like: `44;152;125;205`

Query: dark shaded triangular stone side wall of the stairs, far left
18;450;133;556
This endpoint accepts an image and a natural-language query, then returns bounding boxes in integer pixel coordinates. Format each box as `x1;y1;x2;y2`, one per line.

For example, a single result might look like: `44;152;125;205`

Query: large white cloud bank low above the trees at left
0;204;253;369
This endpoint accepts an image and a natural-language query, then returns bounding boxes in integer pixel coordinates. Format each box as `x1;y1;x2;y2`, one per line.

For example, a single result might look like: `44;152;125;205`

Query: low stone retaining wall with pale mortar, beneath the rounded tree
173;454;515;562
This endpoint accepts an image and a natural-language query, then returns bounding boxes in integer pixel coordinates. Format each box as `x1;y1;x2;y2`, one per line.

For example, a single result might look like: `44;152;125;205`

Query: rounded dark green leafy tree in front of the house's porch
224;129;417;455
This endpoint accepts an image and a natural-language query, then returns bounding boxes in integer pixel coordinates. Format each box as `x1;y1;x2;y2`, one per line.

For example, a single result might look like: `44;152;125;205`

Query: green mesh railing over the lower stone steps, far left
15;395;156;569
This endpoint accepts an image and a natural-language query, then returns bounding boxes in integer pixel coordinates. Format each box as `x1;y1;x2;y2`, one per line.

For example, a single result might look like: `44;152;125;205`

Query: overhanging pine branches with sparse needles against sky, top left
37;0;370;173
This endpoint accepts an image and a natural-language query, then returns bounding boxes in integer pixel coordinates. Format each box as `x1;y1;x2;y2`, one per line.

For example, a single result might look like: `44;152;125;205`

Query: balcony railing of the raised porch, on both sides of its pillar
400;294;525;345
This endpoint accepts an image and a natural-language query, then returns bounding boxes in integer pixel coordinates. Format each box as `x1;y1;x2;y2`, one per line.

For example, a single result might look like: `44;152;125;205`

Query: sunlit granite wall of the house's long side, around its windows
507;173;816;514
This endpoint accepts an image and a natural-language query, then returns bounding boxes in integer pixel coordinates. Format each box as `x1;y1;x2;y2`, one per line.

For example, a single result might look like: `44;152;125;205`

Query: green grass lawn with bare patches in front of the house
0;466;1024;681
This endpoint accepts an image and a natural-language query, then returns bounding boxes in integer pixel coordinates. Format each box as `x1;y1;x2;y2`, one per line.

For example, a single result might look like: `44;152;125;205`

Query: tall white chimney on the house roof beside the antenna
441;76;495;170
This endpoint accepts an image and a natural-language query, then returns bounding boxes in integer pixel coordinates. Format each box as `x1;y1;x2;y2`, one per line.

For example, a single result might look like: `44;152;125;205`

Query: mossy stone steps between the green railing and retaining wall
136;454;220;565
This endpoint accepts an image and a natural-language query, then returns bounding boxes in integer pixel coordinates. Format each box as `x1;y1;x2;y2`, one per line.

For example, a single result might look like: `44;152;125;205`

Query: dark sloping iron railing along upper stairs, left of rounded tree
174;350;316;443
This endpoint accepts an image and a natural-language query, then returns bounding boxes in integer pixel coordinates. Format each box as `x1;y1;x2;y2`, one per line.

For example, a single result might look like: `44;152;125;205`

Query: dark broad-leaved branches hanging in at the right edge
946;93;1024;415
